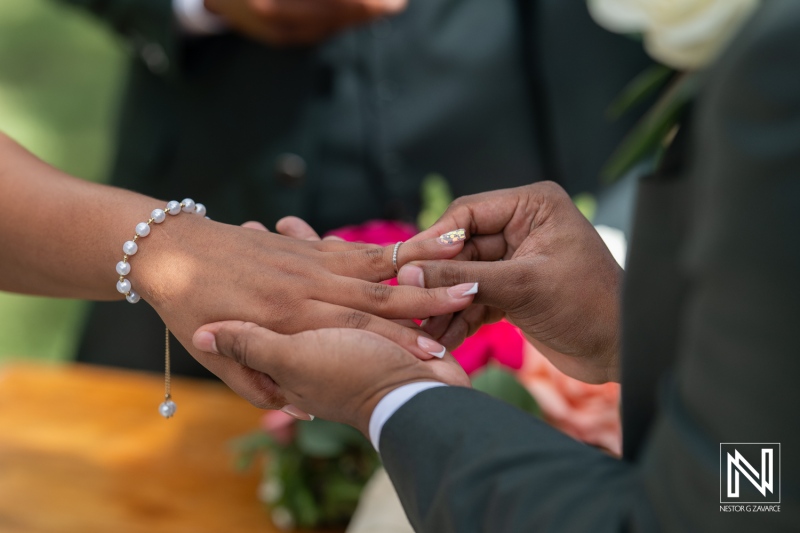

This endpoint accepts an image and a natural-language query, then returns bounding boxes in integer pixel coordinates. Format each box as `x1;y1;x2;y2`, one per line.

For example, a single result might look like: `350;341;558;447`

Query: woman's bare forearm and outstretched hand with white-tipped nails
0;135;472;408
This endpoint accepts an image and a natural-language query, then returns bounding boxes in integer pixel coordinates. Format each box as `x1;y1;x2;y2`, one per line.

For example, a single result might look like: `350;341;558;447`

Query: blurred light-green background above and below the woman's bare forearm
0;0;124;361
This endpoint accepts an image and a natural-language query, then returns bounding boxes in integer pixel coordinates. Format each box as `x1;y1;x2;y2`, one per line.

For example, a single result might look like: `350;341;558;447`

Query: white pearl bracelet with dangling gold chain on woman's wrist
117;198;208;418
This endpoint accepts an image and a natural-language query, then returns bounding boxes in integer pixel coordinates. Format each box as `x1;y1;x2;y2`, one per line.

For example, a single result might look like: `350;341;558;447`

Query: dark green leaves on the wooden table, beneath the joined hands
234;419;380;528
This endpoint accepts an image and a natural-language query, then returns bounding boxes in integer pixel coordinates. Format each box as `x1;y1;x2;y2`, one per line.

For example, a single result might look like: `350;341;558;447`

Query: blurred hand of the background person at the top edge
205;0;406;46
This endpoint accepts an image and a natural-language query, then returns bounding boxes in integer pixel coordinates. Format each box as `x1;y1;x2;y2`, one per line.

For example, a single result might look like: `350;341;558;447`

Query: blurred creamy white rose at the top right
588;0;760;70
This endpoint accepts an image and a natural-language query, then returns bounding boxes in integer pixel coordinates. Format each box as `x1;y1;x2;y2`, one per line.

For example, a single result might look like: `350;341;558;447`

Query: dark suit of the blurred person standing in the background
65;0;648;374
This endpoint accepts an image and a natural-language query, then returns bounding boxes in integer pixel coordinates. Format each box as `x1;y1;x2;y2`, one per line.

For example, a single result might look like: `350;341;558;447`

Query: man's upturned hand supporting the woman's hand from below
193;321;470;434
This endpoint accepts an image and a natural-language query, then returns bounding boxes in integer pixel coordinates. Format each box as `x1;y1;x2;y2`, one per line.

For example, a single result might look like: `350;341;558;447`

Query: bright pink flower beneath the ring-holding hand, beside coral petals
453;320;526;374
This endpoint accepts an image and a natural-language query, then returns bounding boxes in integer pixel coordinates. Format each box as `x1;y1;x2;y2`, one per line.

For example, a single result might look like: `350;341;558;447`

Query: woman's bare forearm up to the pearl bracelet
0;134;164;300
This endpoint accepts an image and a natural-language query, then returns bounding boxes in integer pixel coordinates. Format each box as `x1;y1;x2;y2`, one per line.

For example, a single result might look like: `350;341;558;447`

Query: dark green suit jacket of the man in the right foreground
380;0;800;533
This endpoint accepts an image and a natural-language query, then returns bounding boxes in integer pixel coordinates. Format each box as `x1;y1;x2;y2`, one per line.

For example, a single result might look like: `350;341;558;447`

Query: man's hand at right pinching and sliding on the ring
398;182;622;383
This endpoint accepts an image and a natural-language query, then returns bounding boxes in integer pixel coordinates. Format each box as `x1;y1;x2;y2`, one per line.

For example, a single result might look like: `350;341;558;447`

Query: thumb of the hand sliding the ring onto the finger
397;261;524;310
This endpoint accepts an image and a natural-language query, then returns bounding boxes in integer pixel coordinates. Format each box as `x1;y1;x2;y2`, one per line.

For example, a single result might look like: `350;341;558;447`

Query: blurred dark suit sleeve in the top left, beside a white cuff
60;0;180;75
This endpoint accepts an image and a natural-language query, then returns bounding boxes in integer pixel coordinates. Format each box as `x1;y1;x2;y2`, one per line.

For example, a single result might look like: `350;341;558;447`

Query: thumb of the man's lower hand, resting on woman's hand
192;320;292;374
